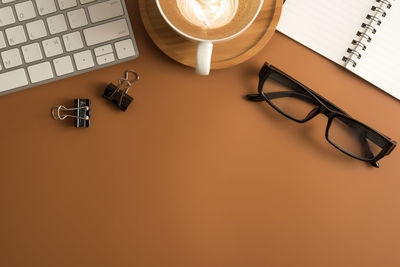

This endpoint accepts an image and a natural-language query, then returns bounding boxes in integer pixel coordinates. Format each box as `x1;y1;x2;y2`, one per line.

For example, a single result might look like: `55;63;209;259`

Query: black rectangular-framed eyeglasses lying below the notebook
247;63;397;168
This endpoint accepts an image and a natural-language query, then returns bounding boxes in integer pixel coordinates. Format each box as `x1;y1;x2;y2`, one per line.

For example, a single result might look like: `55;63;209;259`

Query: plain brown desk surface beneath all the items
0;1;400;267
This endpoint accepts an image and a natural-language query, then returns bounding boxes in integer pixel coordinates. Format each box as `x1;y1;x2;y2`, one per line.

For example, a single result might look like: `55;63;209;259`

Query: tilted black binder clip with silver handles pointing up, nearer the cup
103;70;139;111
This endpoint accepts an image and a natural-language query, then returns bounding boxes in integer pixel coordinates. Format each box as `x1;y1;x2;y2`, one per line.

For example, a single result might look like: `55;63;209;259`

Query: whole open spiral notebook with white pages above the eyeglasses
278;0;400;99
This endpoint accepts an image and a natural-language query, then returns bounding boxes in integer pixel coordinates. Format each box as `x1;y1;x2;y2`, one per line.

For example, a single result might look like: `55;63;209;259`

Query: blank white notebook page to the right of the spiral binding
347;0;400;99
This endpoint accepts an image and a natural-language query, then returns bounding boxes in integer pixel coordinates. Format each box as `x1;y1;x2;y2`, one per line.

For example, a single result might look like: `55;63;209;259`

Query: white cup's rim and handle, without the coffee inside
156;0;264;75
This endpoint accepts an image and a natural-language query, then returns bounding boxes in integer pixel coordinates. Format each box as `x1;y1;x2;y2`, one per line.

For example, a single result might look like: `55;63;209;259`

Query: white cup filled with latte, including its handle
156;0;264;75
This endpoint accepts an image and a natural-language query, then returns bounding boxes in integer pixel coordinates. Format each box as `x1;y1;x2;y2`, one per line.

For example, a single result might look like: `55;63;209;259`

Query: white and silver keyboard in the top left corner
0;0;139;95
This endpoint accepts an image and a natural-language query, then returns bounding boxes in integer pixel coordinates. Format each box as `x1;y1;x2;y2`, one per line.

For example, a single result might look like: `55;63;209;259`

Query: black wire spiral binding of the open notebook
342;0;392;68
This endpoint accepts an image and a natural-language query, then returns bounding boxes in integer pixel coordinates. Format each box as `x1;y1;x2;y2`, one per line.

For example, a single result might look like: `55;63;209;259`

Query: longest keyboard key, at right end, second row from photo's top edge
83;19;129;46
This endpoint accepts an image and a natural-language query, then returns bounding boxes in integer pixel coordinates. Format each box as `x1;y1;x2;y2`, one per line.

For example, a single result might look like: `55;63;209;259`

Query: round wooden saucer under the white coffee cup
139;0;283;69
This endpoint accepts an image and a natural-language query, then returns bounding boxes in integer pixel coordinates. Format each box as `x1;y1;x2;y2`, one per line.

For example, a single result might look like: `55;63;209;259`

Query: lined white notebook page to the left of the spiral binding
278;0;376;65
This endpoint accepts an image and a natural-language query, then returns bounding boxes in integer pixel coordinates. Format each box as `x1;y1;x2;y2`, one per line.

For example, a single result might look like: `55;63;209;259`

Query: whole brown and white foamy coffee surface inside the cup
159;0;262;40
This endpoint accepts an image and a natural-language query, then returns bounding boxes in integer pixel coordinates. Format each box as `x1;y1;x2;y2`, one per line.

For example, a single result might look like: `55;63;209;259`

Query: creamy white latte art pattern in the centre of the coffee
176;0;239;29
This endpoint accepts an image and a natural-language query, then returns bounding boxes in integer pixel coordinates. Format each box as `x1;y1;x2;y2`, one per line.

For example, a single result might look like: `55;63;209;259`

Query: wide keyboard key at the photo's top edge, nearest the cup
88;0;124;23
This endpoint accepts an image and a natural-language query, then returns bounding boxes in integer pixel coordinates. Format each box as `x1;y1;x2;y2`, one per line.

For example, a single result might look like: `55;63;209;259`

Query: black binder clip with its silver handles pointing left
51;98;90;128
